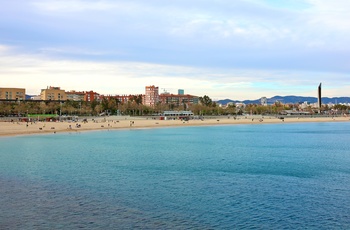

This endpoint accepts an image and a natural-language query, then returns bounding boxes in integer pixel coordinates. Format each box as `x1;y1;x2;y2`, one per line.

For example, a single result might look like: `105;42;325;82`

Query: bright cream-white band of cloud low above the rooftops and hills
0;46;348;99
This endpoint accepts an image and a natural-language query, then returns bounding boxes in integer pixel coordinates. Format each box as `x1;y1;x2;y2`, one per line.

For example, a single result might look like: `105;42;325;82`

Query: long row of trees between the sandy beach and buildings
0;95;350;117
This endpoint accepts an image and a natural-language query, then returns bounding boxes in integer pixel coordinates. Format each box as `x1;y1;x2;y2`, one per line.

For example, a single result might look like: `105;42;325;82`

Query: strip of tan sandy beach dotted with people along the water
0;116;350;138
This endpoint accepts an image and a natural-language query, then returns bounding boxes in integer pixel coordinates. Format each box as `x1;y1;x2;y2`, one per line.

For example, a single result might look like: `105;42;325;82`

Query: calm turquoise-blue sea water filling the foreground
0;123;350;229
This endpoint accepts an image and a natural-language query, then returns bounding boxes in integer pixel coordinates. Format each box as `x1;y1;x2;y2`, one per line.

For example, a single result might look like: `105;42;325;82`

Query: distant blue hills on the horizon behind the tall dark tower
216;96;350;105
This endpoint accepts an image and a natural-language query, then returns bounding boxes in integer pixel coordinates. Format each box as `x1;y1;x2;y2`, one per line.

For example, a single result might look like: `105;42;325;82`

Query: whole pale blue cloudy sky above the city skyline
0;0;350;100
